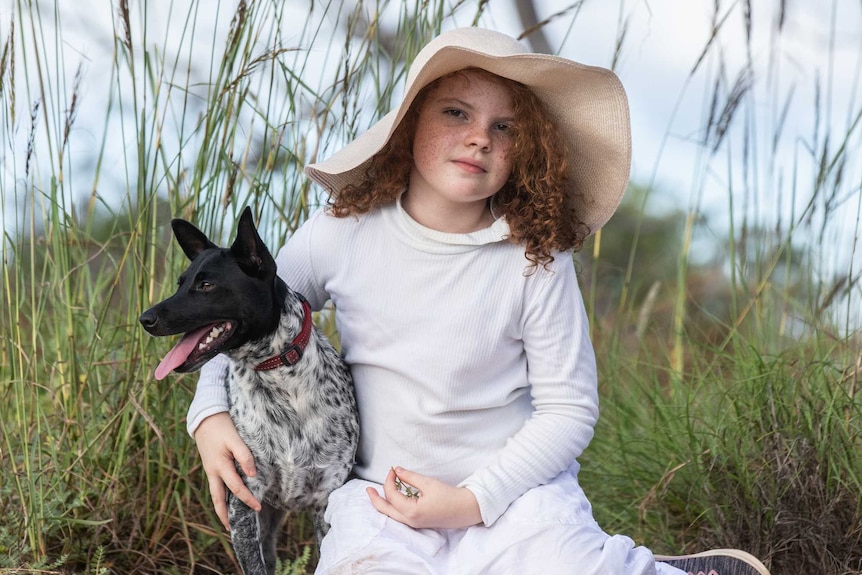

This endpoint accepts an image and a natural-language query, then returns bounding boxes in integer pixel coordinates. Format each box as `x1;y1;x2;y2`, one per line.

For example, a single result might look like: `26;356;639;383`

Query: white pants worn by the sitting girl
316;464;686;575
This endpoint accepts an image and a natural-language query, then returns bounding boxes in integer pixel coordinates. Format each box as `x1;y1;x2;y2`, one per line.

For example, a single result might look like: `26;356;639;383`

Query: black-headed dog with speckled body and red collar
140;207;359;575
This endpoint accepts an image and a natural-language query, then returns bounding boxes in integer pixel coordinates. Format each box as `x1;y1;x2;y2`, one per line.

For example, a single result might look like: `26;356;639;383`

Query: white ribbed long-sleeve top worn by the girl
188;198;598;525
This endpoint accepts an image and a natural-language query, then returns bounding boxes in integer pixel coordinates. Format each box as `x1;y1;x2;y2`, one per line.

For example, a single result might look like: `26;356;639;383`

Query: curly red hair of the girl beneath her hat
329;68;590;266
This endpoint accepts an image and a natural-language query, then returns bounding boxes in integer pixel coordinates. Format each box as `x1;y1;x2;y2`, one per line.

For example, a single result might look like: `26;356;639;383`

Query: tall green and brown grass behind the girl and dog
0;0;862;575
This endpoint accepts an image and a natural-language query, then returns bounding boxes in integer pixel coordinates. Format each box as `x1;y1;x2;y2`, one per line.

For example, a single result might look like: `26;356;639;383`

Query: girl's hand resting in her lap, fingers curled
366;467;482;529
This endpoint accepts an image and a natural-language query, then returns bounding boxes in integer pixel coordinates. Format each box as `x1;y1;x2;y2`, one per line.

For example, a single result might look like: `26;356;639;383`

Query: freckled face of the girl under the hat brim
408;70;515;224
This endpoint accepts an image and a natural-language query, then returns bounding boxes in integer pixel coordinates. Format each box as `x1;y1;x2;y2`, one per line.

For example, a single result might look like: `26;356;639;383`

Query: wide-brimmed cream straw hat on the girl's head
305;28;631;233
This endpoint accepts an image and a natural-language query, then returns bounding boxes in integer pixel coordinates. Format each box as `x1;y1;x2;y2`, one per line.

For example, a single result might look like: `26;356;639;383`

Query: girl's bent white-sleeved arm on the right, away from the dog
460;253;599;525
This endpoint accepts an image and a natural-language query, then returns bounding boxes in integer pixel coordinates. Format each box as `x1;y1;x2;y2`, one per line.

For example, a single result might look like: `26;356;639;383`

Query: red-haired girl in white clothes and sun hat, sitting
188;28;765;575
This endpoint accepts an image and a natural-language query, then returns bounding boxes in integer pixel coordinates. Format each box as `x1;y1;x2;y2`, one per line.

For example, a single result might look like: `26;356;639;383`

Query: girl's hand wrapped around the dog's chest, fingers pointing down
194;412;260;531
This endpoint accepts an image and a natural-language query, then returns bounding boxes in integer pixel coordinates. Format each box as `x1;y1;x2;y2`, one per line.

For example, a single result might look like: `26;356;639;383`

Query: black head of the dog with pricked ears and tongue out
139;207;284;379
